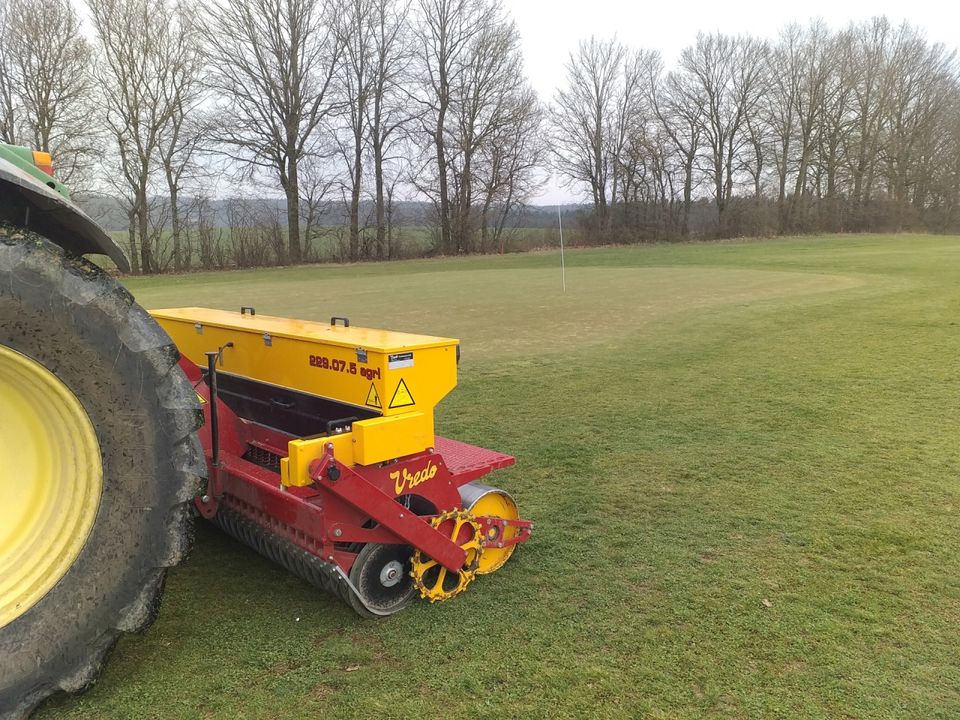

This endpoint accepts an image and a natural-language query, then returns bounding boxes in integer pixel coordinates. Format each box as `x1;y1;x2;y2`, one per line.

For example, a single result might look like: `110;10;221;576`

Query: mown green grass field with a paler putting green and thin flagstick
38;236;960;720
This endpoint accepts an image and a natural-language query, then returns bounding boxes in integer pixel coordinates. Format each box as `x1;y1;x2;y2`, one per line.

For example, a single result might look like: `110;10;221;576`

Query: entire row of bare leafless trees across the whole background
0;0;960;273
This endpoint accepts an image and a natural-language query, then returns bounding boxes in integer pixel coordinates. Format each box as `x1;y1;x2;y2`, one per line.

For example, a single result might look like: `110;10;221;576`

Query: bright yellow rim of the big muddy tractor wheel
0;345;103;628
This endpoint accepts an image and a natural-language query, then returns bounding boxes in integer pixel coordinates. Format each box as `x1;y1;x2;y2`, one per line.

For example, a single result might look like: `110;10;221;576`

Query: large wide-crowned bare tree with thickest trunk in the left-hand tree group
204;0;343;263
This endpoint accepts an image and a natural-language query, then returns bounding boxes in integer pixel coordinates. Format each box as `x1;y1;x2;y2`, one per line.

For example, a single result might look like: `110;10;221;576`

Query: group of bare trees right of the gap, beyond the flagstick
550;17;960;241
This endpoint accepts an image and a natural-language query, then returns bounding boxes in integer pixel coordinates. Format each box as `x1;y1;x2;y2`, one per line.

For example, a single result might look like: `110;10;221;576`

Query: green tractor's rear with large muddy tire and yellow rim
0;145;205;720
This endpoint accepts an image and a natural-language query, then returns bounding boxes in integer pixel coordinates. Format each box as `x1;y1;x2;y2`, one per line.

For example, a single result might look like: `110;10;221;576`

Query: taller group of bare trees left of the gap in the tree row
0;0;545;273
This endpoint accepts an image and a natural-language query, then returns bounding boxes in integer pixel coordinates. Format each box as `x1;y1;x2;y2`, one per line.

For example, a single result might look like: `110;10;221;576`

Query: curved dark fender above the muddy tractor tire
0;158;130;272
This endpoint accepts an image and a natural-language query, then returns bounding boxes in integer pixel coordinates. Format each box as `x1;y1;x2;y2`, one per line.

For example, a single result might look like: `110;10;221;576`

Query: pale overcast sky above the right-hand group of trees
520;0;960;204
